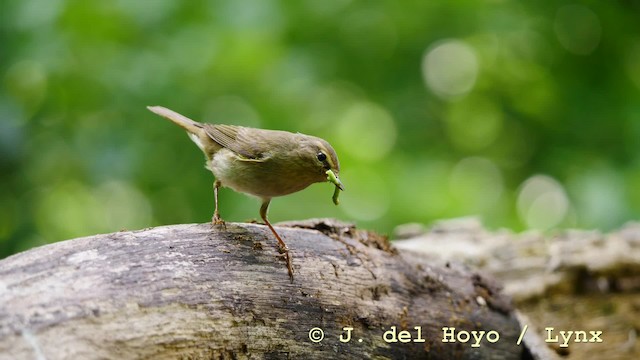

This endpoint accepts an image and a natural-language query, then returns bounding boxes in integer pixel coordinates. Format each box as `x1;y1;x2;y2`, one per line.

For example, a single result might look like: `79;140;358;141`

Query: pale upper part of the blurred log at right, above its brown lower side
395;218;640;302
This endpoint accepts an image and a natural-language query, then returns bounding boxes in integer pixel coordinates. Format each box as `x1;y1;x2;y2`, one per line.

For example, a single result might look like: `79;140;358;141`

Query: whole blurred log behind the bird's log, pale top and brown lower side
395;218;640;360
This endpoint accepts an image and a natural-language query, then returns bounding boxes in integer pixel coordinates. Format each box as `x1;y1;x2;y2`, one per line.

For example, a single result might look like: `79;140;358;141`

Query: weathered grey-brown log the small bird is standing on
0;220;527;359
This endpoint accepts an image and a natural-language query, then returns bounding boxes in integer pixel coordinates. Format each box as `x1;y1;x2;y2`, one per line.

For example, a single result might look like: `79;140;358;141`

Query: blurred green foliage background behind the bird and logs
0;0;640;257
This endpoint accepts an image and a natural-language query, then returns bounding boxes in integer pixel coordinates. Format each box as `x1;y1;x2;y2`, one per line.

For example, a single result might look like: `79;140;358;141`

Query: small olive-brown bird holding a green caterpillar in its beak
147;106;344;281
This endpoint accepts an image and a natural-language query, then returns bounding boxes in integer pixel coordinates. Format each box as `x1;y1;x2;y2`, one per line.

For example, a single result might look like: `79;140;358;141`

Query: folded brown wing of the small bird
203;124;268;161
